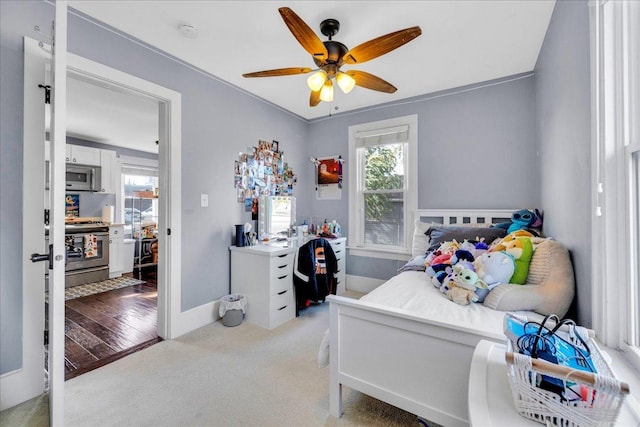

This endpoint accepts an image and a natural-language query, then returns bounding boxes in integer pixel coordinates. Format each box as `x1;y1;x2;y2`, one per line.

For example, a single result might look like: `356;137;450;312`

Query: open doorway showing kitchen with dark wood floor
60;74;162;380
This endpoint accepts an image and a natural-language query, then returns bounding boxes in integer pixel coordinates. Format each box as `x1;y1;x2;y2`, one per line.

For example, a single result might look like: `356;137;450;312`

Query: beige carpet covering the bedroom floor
0;292;442;427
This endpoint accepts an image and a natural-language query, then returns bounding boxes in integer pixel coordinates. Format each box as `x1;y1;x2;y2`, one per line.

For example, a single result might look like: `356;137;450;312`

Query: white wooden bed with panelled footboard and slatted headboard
327;209;568;426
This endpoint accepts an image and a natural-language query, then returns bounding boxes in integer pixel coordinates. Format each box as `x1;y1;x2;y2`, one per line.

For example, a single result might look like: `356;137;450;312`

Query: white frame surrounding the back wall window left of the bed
348;114;418;260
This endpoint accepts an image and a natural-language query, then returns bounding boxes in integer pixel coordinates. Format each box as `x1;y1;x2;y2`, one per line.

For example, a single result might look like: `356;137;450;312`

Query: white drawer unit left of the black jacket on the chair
230;245;298;329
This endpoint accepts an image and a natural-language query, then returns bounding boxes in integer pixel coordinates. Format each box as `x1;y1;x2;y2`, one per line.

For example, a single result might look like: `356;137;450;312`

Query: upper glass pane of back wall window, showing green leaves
364;144;404;190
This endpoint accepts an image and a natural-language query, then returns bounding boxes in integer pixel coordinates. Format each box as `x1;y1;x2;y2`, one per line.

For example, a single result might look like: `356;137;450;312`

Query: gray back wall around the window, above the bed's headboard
309;74;540;279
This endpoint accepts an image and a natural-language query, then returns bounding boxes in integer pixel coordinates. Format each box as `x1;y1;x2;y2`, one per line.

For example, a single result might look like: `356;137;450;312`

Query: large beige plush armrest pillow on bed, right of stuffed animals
484;239;575;318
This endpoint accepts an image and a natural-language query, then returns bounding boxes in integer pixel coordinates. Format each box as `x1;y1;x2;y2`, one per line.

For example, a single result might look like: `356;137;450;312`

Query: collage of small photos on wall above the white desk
234;141;297;214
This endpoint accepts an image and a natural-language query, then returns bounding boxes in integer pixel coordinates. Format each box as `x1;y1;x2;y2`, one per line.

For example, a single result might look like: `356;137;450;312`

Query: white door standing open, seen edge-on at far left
49;0;67;426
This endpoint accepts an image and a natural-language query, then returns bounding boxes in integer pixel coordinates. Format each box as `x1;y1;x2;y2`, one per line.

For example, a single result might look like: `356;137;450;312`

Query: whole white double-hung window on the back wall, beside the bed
349;115;418;256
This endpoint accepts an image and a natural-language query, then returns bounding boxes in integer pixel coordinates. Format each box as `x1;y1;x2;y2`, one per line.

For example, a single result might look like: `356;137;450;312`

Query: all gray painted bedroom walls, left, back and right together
0;0;591;374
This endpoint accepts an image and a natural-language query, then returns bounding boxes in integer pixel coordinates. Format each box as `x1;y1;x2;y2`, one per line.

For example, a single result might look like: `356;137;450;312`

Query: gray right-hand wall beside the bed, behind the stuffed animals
535;1;592;327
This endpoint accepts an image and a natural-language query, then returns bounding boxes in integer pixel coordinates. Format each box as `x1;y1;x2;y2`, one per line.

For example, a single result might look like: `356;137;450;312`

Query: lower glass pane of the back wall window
364;192;404;246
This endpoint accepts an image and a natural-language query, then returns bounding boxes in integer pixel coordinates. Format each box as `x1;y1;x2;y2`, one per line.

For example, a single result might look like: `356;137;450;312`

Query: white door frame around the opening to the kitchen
0;37;182;409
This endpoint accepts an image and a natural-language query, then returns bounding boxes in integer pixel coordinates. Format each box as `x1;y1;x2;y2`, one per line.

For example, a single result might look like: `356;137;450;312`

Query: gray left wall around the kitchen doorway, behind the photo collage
0;0;312;374
